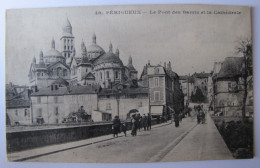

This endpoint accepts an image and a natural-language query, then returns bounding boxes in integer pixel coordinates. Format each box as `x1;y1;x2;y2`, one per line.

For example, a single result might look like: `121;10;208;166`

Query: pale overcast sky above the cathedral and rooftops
6;5;251;85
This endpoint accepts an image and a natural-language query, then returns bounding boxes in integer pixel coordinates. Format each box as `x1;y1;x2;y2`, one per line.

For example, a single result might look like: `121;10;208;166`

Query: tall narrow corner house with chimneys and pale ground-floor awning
139;62;184;117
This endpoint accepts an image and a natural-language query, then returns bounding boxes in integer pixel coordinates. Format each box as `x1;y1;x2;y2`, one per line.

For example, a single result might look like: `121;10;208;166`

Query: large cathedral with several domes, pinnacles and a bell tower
29;19;138;88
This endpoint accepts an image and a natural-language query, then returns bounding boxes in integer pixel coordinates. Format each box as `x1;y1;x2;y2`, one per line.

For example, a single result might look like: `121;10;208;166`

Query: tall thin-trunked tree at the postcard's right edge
236;39;253;123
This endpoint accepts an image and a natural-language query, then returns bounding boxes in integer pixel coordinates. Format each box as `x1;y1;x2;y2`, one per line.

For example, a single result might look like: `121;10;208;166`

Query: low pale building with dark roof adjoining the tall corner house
94;85;149;121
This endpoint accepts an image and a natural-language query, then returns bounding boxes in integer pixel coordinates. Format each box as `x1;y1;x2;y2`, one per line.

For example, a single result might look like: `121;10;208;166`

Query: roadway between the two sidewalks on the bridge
26;118;196;163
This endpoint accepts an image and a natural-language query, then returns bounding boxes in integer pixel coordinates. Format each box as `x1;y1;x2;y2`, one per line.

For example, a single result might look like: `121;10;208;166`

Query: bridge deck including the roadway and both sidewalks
7;111;233;163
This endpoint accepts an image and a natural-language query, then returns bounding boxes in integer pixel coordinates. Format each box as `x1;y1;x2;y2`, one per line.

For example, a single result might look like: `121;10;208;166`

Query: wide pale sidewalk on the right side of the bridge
160;115;234;162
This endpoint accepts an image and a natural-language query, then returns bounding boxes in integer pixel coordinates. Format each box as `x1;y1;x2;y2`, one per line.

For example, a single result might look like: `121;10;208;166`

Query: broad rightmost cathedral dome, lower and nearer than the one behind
94;52;123;66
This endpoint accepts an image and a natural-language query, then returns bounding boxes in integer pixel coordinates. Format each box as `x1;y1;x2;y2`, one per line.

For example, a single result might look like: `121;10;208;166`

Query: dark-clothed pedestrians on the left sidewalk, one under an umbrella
113;114;152;137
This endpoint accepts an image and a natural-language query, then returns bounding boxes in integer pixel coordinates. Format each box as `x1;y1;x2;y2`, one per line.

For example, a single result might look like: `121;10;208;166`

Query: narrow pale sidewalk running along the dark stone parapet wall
7;122;169;161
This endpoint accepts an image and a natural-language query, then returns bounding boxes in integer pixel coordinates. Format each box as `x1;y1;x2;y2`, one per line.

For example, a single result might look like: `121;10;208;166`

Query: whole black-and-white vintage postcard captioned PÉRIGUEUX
5;5;254;163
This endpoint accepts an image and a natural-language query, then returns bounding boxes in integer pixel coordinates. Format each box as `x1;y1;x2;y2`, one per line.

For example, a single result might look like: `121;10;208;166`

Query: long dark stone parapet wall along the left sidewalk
6;119;159;153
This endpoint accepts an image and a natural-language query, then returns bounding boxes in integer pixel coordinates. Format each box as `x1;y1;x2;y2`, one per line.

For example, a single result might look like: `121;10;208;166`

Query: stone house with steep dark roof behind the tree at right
213;57;253;116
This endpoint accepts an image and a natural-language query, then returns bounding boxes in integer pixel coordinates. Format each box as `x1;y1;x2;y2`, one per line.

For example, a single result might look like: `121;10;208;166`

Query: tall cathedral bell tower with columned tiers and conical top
60;18;74;62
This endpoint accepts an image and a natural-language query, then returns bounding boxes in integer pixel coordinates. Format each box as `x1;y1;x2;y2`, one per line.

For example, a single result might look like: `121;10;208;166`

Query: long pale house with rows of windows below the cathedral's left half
31;84;98;124
